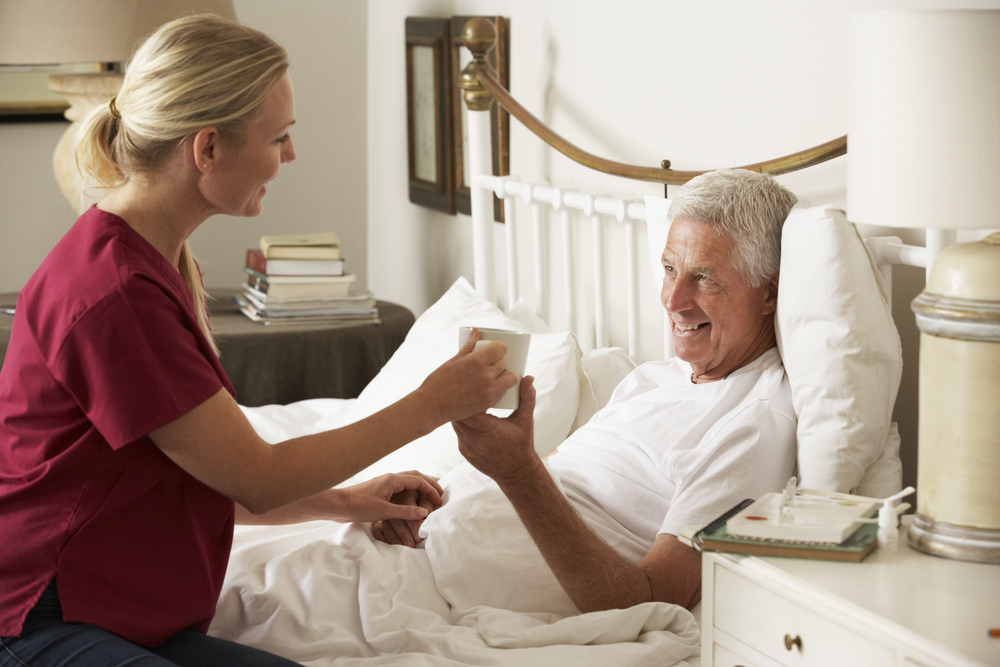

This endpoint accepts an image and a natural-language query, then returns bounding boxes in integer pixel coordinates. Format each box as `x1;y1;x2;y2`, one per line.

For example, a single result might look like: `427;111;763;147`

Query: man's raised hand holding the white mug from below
452;375;541;487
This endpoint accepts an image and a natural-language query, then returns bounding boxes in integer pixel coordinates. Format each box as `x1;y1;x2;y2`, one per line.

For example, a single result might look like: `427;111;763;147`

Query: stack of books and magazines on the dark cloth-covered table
236;232;378;324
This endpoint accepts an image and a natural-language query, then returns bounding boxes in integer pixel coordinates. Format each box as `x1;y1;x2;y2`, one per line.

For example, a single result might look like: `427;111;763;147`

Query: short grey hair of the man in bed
667;169;798;287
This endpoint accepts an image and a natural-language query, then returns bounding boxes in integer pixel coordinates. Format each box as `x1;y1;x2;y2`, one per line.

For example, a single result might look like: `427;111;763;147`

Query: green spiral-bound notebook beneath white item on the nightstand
678;494;878;562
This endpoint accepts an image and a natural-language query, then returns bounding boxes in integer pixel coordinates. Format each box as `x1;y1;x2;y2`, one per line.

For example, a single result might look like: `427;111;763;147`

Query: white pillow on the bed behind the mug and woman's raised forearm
354;278;580;481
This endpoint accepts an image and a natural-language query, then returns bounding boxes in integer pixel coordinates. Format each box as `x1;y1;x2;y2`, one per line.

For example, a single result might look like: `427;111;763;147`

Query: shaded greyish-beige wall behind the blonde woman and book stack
0;0;368;292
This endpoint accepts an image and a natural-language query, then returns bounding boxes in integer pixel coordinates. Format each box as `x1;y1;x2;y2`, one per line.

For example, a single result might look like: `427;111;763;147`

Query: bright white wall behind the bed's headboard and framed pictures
368;0;1000;496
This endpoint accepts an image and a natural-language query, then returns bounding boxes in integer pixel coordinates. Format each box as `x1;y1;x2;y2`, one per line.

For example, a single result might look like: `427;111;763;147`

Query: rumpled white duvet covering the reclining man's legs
210;401;700;667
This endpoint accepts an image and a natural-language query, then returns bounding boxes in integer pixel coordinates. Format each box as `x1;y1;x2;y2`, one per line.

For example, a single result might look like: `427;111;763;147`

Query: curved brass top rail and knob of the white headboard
458;17;847;185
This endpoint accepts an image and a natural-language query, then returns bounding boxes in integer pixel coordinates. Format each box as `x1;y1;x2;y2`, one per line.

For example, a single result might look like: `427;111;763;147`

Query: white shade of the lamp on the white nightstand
847;10;1000;229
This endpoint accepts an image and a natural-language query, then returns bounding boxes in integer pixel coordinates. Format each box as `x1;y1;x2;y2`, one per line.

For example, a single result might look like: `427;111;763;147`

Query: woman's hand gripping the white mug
417;328;517;423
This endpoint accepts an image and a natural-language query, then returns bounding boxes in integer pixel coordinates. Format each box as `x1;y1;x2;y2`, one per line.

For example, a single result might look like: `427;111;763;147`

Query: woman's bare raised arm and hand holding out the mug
150;332;517;514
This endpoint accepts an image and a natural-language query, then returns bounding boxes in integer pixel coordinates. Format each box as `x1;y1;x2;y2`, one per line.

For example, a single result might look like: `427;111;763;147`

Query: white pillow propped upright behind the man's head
776;206;903;497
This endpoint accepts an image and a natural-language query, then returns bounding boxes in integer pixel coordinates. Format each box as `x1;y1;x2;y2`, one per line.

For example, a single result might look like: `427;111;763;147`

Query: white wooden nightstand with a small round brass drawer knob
701;517;1000;667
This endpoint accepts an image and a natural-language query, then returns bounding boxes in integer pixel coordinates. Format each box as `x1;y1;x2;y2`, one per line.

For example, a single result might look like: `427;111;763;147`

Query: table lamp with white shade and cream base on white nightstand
847;10;1000;563
